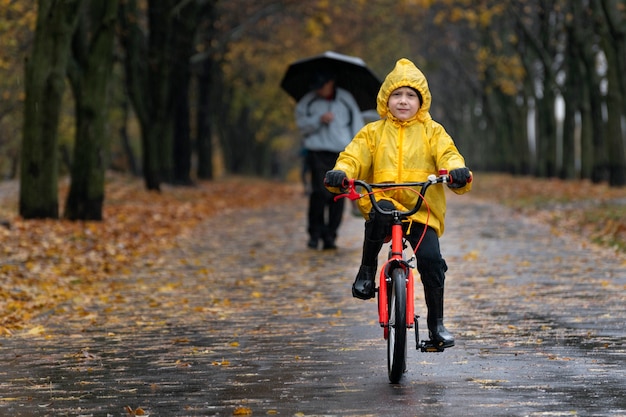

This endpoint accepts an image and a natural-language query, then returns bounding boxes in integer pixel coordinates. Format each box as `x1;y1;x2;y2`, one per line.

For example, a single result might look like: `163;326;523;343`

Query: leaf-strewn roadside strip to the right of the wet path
471;173;626;252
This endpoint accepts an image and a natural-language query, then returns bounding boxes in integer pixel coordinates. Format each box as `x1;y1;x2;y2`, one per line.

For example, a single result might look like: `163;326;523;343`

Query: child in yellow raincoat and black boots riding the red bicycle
324;58;472;348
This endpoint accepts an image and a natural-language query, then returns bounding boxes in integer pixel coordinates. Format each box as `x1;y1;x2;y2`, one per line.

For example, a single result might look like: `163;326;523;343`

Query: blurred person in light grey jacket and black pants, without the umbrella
295;70;364;249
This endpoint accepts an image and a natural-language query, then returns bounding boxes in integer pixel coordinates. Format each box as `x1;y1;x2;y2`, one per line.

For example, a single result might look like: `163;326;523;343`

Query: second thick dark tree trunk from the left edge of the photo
64;0;118;220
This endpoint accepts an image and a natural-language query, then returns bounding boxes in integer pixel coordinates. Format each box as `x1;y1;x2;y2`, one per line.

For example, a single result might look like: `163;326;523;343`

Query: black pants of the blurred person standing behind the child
307;150;344;243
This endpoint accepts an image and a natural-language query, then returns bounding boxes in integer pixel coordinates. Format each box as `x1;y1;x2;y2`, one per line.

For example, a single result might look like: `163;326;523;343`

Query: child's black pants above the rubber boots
362;201;448;289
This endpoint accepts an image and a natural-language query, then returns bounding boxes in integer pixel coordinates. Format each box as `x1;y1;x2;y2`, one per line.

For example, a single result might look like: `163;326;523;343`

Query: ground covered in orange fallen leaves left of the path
0;177;301;336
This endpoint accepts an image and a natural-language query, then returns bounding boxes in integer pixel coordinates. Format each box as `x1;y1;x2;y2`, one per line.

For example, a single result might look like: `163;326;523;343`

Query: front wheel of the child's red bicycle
387;268;407;384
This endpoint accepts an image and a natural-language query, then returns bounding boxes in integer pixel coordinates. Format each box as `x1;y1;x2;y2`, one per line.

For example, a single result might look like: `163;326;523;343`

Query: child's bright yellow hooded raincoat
330;58;471;236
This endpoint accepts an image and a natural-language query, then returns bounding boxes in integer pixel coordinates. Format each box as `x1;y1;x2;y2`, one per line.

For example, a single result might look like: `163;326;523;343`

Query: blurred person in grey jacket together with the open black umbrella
280;51;381;249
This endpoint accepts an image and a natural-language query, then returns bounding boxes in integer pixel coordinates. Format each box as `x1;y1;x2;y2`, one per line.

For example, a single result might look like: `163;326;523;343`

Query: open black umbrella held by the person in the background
280;51;381;111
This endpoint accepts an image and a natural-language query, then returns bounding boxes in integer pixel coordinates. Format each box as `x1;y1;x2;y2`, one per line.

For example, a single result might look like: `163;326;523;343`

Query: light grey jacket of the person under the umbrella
296;88;364;153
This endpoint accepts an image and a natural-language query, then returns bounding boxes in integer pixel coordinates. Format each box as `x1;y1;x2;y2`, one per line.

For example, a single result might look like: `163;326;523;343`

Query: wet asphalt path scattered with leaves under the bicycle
0;187;626;417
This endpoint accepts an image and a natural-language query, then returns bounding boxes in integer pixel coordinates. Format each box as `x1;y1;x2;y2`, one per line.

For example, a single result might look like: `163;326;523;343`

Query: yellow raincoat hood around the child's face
376;58;432;123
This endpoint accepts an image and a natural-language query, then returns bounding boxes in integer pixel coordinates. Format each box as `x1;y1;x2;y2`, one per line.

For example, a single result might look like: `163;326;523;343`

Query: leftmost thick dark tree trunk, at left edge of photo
19;0;82;219
